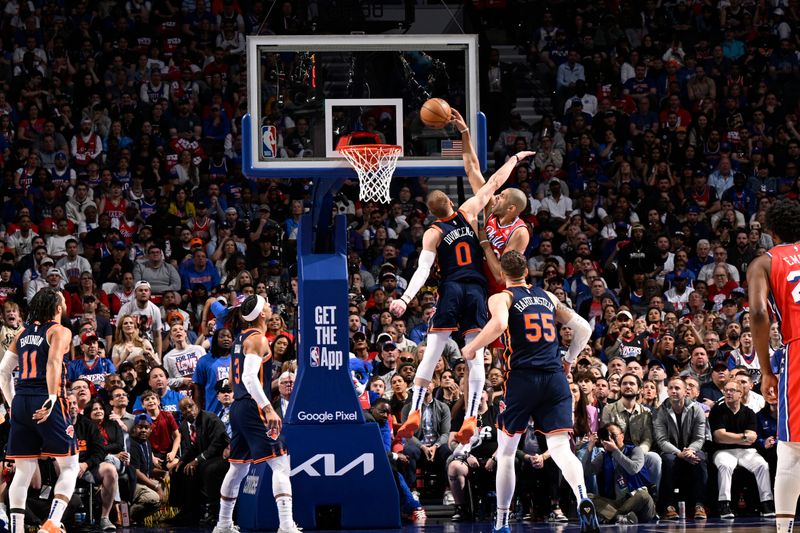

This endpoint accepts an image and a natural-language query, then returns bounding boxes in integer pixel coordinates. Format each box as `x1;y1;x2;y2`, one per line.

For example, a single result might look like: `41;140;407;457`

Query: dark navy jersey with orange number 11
16;322;67;397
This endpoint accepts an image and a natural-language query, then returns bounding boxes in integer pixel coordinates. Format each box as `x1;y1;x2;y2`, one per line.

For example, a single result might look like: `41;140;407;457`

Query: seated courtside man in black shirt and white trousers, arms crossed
708;381;775;518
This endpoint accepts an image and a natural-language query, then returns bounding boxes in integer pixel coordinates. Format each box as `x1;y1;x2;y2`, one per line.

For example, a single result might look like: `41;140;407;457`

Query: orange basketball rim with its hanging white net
339;144;401;204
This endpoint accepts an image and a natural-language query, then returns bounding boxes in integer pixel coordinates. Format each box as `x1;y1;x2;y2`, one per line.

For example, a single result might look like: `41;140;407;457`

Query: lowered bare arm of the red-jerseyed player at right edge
747;255;778;401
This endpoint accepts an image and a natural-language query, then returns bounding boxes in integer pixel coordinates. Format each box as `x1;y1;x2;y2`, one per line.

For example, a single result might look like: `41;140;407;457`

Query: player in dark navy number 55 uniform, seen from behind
462;251;599;533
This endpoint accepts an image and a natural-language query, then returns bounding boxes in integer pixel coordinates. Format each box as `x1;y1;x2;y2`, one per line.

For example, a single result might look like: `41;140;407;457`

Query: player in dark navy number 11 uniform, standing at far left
0;288;79;533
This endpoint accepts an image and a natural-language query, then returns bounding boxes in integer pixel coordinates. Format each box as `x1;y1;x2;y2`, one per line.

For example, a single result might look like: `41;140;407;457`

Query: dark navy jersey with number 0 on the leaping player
431;211;486;284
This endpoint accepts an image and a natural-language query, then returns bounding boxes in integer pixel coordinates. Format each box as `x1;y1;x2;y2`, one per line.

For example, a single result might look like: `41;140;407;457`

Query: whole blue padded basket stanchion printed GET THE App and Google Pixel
236;212;400;530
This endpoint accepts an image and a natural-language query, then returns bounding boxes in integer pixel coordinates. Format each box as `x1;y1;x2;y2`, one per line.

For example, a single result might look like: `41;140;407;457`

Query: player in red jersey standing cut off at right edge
747;200;800;533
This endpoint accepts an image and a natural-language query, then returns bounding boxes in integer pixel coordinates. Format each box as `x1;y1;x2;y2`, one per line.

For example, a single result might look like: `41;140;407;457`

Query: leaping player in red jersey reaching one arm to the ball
451;109;530;296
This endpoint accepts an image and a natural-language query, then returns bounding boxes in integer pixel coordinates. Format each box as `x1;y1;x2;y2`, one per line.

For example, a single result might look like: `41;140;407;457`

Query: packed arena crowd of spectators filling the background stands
0;0;800;531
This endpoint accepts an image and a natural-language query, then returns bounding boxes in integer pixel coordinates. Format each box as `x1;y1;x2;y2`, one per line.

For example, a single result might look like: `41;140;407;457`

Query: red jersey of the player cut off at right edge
767;244;800;344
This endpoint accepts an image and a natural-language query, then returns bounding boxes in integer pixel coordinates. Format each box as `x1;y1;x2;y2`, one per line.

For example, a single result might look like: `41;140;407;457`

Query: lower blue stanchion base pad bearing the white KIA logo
236;423;400;531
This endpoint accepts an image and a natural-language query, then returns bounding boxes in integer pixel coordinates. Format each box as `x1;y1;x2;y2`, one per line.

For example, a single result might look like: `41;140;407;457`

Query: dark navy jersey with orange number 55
503;286;562;372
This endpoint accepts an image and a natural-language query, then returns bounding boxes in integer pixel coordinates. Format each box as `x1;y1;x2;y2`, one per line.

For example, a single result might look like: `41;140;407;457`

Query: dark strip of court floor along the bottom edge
117;518;775;533
